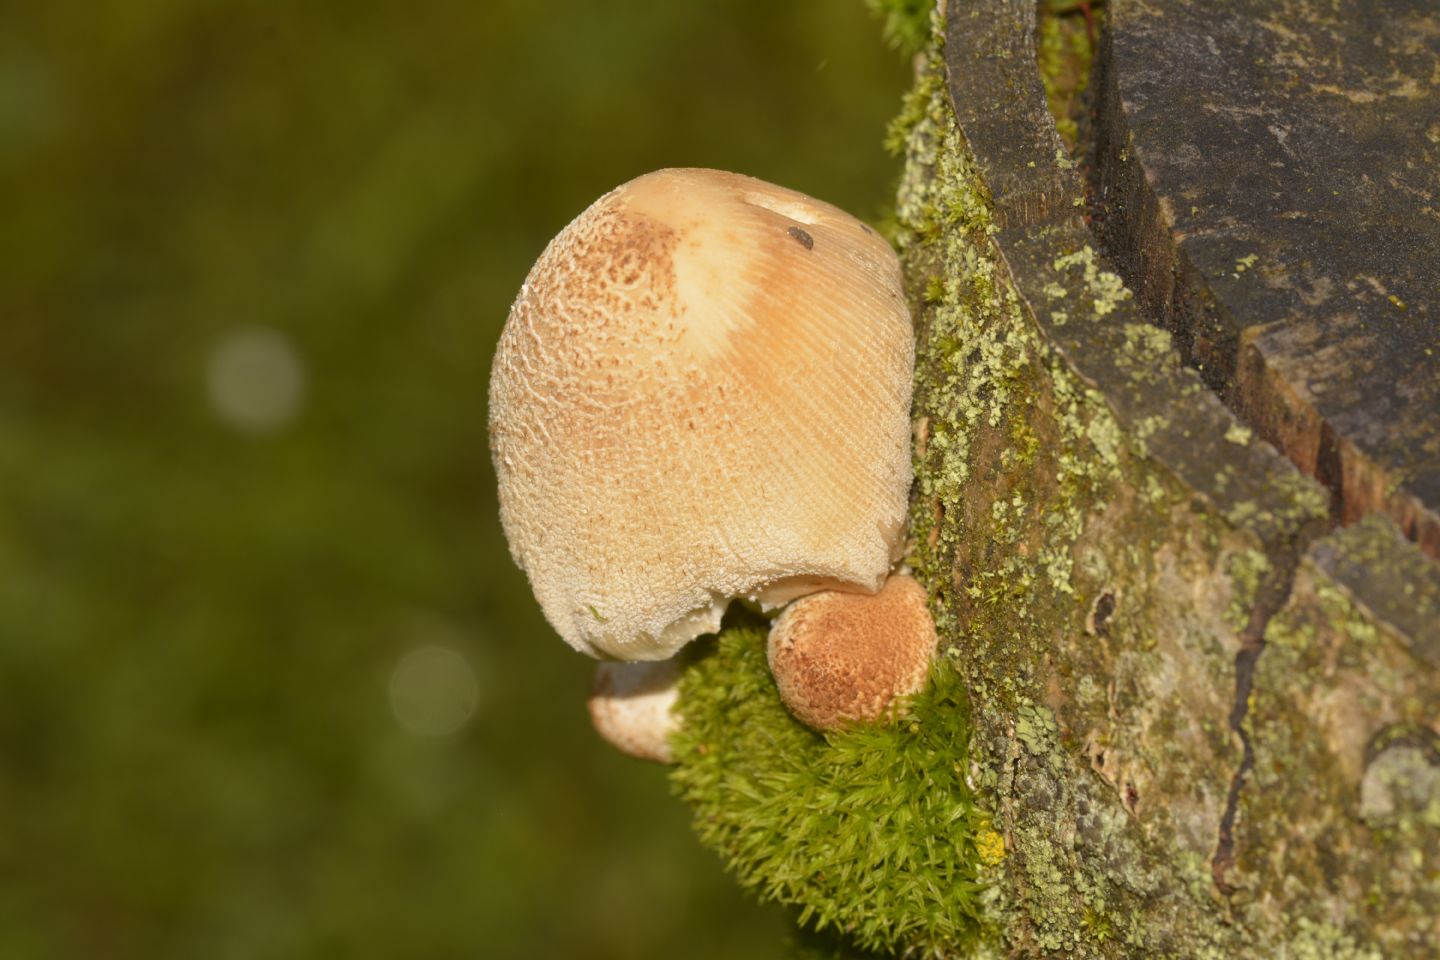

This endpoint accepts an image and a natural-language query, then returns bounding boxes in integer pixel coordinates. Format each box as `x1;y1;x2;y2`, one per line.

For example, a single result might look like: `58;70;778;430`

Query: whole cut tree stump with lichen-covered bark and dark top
899;0;1440;959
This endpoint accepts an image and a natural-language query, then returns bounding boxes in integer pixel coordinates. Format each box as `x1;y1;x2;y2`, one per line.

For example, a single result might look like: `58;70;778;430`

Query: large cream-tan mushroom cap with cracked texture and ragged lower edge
490;170;914;659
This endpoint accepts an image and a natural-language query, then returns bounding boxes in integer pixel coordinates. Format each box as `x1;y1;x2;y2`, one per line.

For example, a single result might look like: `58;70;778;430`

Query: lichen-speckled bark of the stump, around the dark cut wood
897;0;1440;957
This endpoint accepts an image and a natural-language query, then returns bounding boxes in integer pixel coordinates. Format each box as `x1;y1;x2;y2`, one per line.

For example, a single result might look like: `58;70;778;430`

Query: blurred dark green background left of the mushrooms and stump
0;0;907;960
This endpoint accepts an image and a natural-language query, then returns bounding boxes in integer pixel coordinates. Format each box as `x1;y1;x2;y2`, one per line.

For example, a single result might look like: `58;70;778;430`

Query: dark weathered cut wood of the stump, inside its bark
1094;0;1440;556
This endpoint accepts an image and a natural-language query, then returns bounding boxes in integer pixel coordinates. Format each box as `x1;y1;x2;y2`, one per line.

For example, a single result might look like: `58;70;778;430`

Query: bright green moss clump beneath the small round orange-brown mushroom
672;622;995;951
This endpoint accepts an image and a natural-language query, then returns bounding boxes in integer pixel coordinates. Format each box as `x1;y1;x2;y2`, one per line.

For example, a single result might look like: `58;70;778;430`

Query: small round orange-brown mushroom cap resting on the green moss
768;576;939;731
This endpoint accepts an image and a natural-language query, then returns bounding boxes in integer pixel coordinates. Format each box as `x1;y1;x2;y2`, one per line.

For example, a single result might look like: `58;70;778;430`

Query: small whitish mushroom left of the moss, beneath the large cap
589;659;680;763
